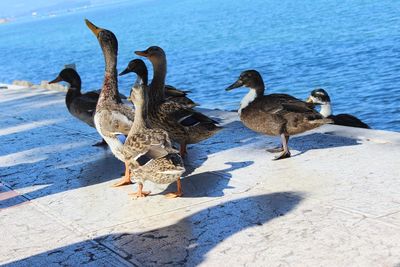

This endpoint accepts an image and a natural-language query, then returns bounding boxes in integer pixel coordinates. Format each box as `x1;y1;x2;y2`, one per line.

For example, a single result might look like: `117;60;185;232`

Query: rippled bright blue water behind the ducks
0;0;400;131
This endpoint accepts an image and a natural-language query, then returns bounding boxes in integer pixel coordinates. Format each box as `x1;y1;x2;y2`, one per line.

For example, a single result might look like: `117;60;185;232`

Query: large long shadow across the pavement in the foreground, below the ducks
5;192;303;266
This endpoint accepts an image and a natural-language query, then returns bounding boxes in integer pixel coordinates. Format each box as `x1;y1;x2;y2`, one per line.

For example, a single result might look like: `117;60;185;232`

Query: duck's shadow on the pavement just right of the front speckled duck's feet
157;161;254;197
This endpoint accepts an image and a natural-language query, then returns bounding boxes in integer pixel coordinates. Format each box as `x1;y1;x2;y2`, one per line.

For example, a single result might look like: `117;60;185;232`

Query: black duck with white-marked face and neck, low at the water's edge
306;88;371;129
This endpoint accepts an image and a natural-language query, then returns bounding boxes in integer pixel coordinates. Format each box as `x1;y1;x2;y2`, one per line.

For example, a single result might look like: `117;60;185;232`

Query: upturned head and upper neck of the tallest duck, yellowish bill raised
85;19;118;68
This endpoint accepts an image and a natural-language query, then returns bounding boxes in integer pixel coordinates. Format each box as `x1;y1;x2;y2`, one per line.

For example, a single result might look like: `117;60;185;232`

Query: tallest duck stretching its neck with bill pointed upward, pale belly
85;19;135;186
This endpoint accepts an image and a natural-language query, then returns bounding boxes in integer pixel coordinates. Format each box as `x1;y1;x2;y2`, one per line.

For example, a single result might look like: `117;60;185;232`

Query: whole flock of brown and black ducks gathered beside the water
50;20;369;198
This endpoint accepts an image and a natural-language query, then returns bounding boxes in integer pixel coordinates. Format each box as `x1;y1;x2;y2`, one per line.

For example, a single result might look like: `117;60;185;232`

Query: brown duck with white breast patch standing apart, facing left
225;70;332;160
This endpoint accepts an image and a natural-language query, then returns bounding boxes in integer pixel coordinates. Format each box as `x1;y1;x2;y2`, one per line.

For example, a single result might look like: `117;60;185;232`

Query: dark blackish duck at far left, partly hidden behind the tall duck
49;68;126;146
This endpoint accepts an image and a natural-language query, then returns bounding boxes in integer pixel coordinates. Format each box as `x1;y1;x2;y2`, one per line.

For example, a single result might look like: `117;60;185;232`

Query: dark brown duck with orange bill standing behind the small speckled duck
135;46;222;157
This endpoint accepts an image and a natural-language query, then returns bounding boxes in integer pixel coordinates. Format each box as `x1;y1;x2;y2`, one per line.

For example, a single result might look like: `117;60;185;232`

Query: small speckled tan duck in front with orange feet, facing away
123;60;185;197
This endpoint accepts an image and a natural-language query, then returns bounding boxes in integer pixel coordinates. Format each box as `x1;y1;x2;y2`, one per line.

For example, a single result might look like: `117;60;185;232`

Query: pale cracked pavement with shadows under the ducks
0;86;400;266
